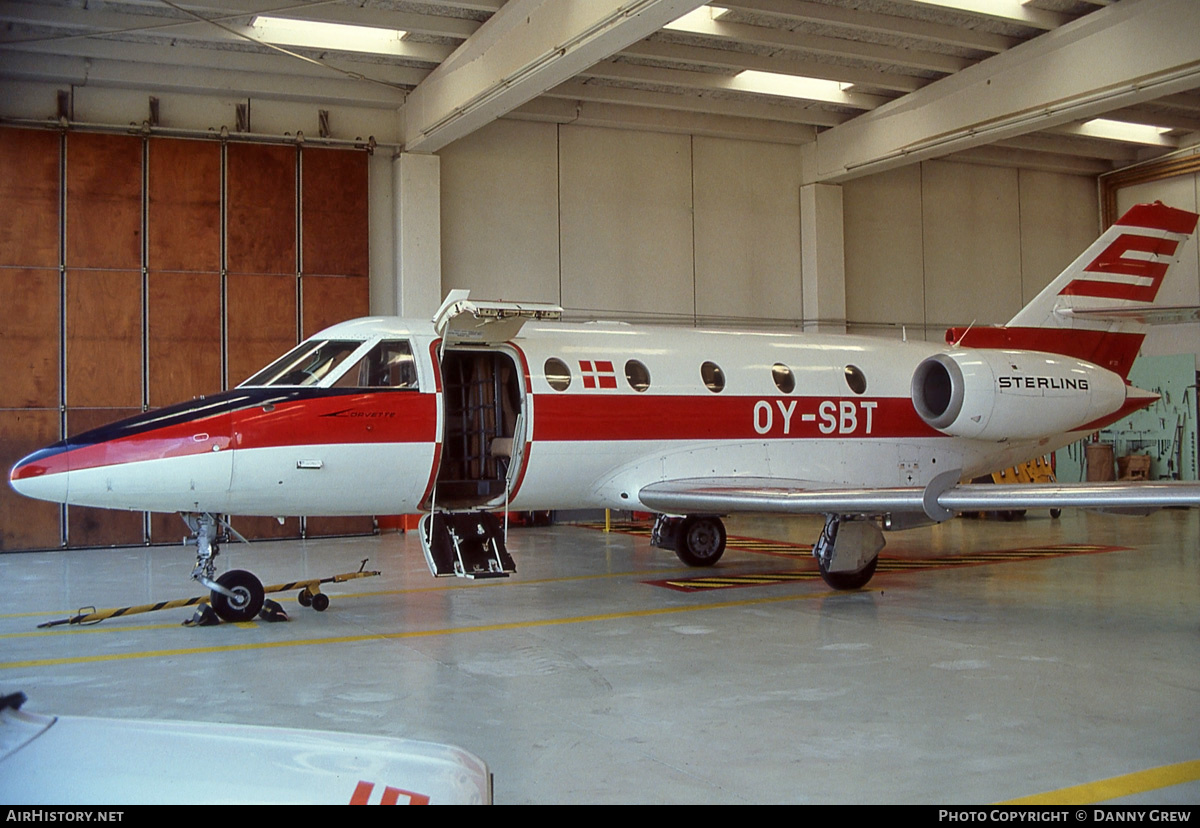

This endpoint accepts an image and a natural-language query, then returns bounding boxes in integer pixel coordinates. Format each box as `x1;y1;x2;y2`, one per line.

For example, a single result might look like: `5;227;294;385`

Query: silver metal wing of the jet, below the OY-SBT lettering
638;470;1200;521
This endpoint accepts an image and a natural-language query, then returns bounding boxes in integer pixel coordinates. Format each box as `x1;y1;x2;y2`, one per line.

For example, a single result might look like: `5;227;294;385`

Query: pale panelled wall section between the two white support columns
439;120;804;323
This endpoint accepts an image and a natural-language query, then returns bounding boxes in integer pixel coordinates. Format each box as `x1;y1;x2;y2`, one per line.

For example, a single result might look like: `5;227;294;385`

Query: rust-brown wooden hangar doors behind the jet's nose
0;133;372;550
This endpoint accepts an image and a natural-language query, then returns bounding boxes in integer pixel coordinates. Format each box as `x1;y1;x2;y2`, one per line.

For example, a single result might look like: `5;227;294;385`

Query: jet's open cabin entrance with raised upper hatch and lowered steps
421;290;562;577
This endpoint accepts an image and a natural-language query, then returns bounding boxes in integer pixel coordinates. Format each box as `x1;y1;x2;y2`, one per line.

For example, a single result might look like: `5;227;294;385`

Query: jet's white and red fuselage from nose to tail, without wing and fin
4;317;1150;516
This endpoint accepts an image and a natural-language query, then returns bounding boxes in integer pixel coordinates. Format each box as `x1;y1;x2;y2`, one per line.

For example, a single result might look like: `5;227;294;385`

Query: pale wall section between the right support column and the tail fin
842;161;1100;341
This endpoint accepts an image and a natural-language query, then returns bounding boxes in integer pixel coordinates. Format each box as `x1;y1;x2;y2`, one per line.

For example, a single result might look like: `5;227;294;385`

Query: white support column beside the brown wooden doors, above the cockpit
392;152;442;317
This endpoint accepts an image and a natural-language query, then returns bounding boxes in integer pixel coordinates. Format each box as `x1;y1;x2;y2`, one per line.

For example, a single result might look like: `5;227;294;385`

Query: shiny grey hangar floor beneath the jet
0;510;1200;804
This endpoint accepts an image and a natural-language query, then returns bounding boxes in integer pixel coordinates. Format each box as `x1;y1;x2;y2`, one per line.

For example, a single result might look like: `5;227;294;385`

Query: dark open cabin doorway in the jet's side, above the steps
433;348;524;511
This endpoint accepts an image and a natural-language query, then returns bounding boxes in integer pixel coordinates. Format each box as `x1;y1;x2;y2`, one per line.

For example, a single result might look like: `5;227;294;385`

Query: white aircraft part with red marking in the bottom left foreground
0;694;492;801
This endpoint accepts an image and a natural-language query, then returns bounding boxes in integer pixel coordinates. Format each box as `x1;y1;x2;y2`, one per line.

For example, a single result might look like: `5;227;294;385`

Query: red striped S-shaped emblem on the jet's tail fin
1058;204;1195;302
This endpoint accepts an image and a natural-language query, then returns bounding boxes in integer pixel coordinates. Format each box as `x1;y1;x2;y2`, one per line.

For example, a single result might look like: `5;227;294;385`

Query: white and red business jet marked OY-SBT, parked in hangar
11;203;1200;619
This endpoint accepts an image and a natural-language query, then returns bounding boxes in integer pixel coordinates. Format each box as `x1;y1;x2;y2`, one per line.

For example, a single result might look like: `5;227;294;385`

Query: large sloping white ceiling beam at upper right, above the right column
804;0;1200;182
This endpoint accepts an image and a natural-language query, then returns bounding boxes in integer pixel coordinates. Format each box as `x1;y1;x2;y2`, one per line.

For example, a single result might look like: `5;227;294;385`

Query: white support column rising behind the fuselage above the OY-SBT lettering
800;184;846;334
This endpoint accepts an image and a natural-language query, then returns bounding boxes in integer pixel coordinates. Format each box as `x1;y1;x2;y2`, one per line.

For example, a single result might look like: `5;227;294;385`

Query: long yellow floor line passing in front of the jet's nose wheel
0;589;859;670
